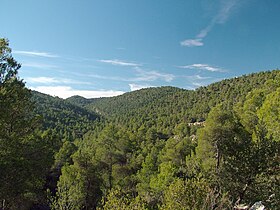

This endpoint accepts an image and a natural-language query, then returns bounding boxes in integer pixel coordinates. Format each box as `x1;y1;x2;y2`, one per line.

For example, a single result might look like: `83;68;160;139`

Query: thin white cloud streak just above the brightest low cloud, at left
25;77;91;85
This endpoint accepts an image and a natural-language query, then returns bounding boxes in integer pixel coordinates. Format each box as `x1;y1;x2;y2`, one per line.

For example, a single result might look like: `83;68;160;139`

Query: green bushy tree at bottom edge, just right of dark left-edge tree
52;145;101;210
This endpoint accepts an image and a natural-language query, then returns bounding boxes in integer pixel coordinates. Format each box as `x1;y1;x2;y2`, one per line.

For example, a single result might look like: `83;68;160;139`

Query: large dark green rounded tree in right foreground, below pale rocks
197;105;255;201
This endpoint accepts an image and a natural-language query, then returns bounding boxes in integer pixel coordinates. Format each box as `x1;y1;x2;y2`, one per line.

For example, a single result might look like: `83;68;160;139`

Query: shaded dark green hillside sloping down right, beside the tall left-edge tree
32;91;100;138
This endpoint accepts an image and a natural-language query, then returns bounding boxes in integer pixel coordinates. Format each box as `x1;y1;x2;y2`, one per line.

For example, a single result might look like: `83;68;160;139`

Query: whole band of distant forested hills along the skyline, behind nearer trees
30;70;280;136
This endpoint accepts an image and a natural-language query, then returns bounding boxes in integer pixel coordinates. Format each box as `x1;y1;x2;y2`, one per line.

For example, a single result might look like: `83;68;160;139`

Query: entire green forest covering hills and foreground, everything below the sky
0;39;280;210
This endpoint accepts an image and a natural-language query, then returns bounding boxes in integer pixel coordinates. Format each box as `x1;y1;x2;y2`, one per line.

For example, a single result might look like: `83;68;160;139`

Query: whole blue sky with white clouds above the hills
0;0;280;98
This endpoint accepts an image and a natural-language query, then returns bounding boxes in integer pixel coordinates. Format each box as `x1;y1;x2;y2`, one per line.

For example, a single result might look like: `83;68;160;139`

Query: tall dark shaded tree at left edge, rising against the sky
0;39;54;209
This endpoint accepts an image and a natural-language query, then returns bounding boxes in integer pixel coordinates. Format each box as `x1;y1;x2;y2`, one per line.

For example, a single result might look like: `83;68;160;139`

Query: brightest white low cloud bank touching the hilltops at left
30;86;125;98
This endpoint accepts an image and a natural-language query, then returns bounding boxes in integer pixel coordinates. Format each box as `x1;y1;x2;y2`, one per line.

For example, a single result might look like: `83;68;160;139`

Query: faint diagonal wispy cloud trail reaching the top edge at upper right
180;0;240;47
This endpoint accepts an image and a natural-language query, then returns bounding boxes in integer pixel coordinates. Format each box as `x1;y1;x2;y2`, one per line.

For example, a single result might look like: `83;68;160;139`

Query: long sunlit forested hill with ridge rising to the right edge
72;70;280;130
